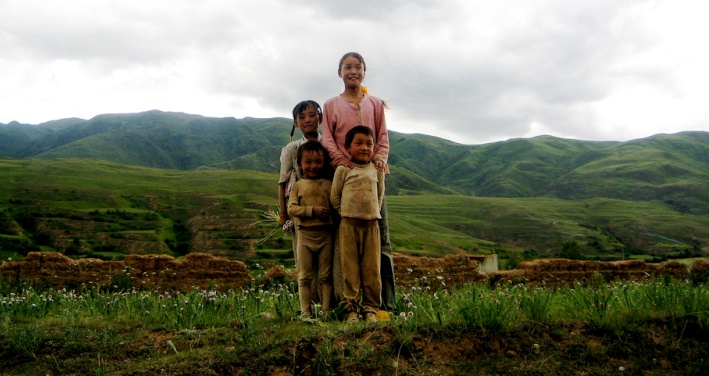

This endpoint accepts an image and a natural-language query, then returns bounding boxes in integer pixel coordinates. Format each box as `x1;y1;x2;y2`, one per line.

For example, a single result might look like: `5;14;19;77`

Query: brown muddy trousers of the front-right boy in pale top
339;218;382;314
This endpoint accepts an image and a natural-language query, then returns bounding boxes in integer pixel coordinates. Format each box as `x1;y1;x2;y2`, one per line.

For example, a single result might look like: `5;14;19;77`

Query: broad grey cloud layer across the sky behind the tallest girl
0;0;708;142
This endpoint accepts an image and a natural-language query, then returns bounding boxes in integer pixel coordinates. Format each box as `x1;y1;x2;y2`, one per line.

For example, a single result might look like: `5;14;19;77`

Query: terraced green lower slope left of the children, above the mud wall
0;159;275;258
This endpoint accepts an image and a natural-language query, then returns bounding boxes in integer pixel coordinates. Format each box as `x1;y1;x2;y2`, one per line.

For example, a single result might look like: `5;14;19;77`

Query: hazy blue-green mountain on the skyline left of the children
30;112;277;170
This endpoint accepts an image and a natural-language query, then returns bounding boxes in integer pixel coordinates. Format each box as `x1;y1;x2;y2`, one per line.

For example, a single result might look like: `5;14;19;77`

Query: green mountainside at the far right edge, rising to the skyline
550;132;709;213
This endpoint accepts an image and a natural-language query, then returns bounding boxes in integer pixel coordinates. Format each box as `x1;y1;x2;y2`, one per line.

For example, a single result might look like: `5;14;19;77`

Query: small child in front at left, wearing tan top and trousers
288;141;333;318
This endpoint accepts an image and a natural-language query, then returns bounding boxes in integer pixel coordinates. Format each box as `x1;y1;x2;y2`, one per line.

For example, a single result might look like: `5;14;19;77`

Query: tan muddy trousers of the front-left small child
297;230;334;316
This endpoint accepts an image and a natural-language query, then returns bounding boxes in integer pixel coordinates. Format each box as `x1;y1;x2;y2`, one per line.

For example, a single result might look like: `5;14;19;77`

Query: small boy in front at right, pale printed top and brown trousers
330;125;384;323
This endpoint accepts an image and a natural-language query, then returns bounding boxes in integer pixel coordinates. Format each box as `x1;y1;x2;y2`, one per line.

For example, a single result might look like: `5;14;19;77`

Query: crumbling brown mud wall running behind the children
0;252;709;290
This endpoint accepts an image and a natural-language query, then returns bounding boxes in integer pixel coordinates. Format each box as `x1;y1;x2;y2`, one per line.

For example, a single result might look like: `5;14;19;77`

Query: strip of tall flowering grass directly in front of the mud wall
0;278;709;330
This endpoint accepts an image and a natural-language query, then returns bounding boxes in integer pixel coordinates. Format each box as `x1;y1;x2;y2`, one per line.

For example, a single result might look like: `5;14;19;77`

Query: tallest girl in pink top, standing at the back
322;52;395;311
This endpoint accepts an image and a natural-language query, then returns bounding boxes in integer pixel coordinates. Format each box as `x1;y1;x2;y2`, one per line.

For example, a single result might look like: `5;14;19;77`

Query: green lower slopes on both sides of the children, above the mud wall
0;159;709;264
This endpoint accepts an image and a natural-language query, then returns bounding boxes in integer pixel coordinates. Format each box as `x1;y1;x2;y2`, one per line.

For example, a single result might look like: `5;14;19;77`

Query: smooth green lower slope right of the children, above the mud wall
387;195;709;254
